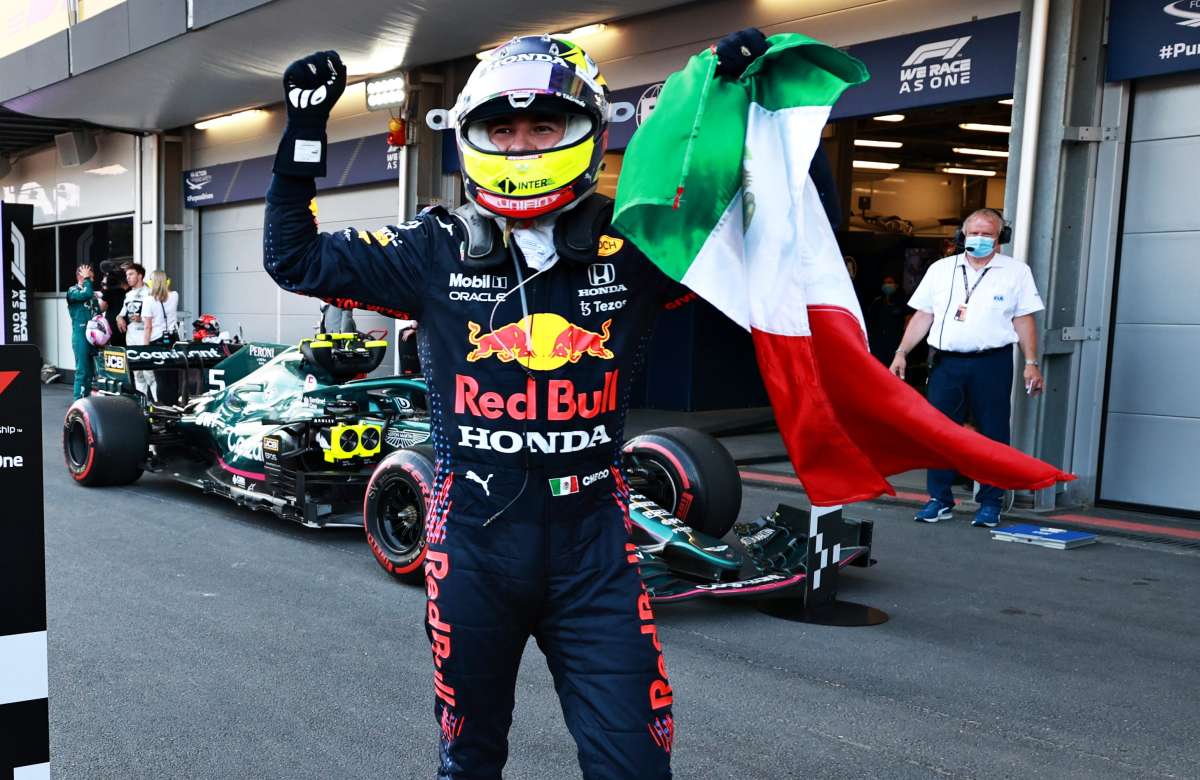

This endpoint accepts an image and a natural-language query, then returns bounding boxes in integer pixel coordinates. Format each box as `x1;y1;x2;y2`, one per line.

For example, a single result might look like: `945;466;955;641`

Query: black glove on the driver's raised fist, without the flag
274;52;346;179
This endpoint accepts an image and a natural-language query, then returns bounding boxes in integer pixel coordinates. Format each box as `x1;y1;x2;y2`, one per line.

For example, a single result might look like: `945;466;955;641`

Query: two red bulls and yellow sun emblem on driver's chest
467;313;613;371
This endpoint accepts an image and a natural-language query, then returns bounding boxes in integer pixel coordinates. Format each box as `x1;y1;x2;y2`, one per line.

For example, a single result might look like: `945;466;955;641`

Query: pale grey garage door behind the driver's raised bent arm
200;185;396;372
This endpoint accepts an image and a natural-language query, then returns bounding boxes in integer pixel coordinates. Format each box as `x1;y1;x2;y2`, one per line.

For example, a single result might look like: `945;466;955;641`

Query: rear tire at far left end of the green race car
62;396;150;487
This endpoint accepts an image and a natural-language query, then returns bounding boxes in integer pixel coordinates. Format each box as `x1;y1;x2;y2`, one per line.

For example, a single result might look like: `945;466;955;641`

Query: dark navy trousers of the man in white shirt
926;348;1013;506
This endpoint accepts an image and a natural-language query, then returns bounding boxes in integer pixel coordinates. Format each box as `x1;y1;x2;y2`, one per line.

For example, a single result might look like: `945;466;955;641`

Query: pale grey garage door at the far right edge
1099;73;1200;511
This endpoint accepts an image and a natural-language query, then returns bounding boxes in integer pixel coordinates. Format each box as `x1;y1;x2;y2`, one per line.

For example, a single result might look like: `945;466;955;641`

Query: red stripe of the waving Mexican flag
752;306;1074;505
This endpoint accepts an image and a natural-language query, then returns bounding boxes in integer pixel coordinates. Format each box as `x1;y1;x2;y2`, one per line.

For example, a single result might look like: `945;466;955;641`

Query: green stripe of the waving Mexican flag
613;34;869;281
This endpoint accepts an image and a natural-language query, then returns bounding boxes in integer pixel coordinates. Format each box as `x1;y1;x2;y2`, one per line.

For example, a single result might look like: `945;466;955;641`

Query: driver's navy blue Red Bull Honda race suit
264;175;680;780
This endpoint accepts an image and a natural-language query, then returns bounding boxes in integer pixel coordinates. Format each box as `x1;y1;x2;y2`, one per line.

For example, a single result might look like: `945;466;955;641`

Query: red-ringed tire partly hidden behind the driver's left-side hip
362;446;433;583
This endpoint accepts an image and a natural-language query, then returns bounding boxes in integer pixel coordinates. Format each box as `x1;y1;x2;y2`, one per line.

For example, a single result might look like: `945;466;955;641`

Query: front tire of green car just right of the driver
623;427;742;539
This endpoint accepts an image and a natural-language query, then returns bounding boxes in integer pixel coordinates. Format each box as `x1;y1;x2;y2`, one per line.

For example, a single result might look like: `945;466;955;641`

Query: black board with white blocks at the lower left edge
0;344;50;780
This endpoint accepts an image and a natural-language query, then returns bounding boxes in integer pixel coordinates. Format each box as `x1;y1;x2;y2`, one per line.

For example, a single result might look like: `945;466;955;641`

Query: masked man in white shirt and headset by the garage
892;209;1045;528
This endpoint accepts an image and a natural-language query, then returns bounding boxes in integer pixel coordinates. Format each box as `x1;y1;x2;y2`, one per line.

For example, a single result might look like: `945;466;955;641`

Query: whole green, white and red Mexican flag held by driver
613;34;1073;505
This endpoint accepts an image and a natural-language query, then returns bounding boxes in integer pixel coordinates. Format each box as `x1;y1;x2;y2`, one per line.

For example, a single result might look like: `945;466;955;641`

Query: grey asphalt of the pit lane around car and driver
43;385;1200;780
